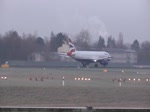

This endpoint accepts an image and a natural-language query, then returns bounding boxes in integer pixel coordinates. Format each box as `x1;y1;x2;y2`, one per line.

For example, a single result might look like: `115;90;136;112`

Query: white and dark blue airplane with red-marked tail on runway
67;38;111;67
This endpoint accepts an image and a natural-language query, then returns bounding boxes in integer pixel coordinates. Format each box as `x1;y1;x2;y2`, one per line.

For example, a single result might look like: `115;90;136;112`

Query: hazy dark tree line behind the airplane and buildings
0;30;150;64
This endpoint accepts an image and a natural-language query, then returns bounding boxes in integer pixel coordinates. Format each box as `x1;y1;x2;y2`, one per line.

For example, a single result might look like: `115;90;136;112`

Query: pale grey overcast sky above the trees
0;0;150;43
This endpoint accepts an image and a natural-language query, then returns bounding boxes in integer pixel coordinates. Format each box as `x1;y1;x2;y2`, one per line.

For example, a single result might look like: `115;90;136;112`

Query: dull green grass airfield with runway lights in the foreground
0;68;150;108
